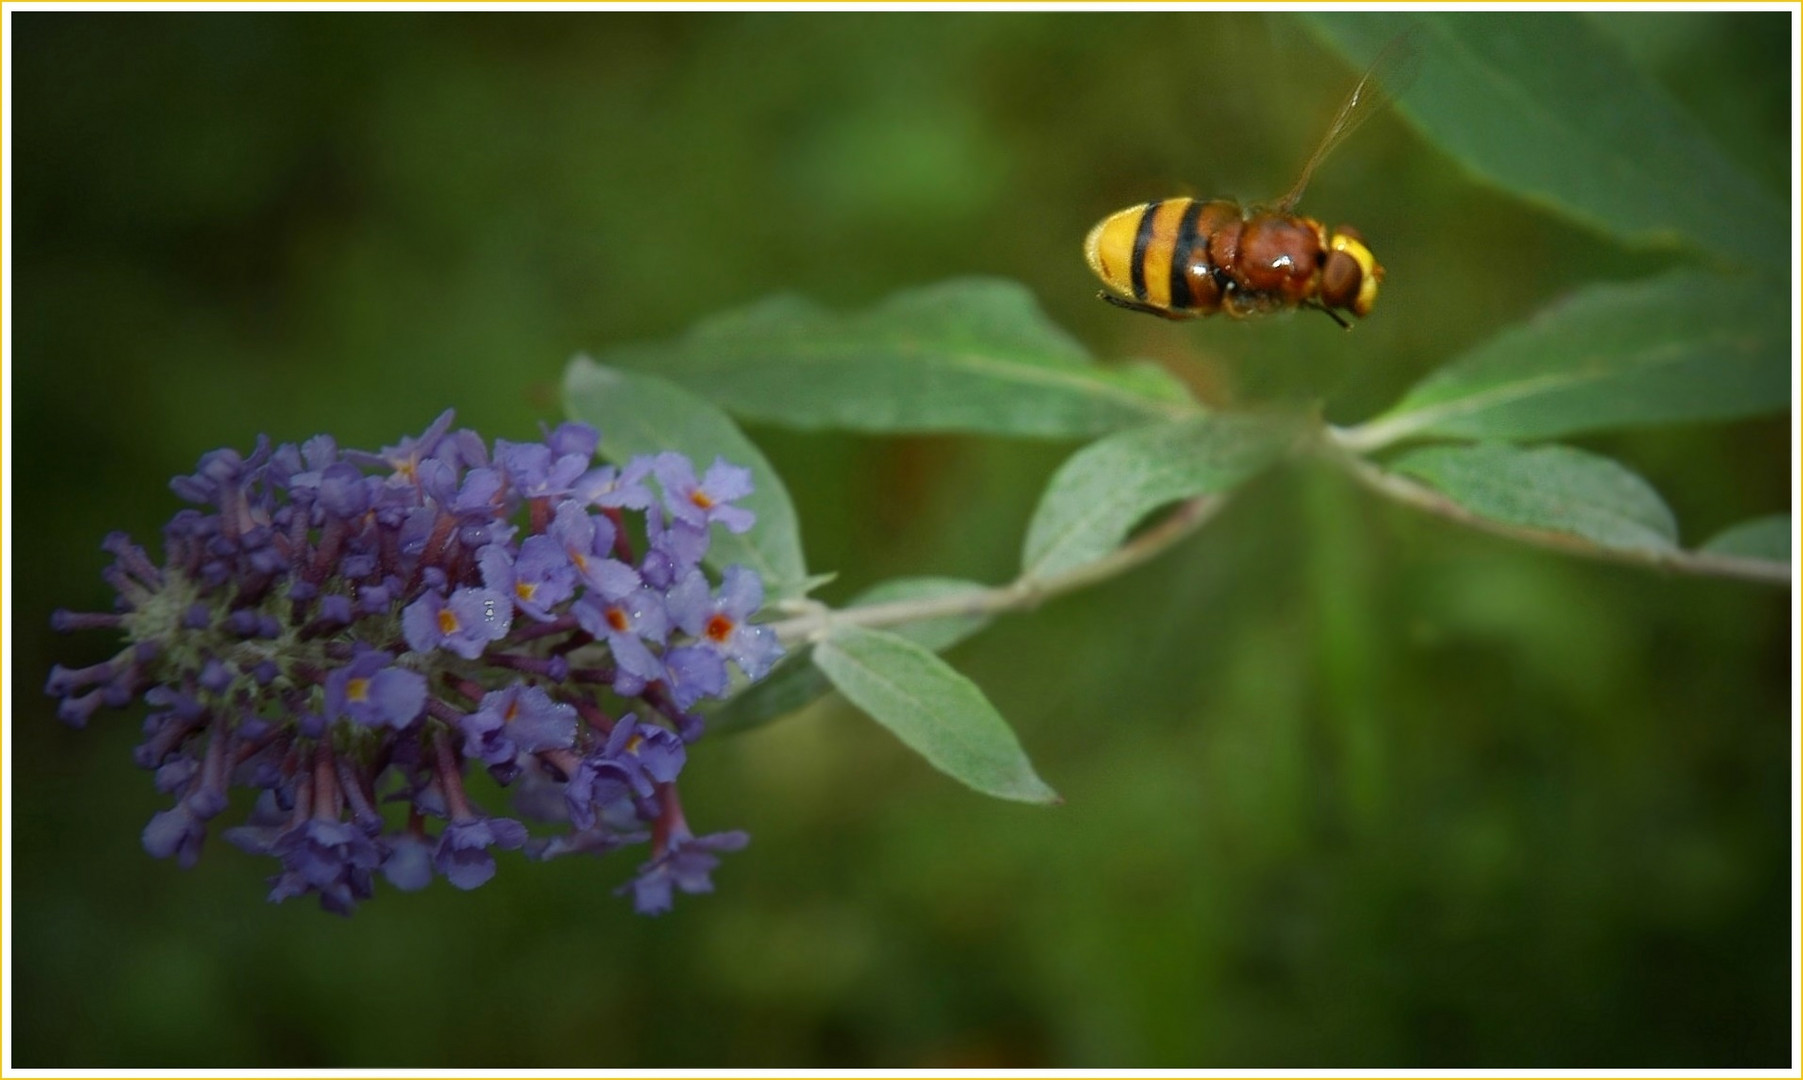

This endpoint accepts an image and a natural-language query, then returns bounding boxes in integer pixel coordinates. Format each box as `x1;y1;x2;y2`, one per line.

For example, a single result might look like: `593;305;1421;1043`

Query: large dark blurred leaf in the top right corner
1313;11;1792;269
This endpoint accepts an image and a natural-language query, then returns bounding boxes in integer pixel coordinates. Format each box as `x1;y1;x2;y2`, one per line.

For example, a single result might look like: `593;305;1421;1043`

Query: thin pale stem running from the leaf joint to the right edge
1316;427;1790;584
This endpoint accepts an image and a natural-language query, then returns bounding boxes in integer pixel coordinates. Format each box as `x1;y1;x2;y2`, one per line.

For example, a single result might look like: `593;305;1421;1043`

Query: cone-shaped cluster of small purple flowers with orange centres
45;411;781;914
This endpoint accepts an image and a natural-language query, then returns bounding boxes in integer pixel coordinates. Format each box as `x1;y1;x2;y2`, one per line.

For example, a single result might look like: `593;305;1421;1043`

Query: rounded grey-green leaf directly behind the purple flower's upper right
564;357;808;600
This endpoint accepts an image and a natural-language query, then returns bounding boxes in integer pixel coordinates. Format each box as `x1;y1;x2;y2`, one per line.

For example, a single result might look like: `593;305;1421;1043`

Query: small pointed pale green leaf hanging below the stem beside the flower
813;626;1060;802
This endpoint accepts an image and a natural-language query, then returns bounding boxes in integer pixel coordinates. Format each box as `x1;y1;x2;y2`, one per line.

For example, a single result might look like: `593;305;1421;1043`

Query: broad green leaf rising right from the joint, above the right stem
1350;270;1790;447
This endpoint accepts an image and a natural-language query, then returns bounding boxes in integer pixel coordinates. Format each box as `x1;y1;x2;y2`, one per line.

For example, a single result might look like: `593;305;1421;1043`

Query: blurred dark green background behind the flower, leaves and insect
7;13;1792;1067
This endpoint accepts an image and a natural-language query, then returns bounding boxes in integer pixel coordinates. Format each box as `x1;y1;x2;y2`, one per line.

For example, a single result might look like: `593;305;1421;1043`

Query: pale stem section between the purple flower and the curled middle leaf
766;494;1226;645
